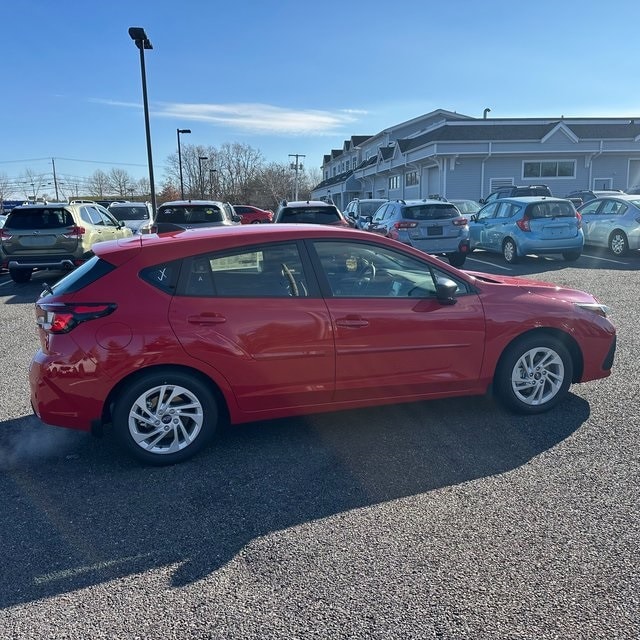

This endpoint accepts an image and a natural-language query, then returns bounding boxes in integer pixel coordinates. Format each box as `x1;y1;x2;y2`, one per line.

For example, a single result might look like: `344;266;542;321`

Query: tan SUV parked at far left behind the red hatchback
0;202;133;282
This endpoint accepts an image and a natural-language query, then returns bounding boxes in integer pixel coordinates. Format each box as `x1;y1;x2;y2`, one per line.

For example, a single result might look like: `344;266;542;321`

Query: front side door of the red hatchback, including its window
313;240;485;402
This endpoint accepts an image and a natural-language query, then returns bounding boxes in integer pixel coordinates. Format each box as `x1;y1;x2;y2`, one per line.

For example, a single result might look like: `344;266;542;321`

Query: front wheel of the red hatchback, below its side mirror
494;334;573;414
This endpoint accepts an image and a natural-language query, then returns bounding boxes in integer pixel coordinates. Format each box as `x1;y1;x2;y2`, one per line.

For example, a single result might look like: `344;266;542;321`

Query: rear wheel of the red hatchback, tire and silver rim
113;369;219;465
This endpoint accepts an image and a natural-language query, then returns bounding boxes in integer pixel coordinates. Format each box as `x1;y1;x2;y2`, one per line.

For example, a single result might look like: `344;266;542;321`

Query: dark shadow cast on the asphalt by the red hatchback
0;395;589;607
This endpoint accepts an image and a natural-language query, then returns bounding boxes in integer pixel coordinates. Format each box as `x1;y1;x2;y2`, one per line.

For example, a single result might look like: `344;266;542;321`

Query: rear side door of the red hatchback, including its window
169;243;335;412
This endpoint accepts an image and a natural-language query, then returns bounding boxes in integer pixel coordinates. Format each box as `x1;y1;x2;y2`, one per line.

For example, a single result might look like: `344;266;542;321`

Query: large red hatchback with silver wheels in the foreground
30;224;616;464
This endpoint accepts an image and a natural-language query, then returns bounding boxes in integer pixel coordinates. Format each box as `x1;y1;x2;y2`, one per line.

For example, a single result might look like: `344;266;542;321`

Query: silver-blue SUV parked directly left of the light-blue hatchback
366;199;469;267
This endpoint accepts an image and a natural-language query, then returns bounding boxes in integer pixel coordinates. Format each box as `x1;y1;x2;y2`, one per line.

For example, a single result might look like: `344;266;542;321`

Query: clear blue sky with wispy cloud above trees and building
0;0;640;195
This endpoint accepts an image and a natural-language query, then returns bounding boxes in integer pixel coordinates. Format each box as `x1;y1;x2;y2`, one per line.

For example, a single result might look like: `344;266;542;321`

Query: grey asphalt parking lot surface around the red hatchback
0;251;640;640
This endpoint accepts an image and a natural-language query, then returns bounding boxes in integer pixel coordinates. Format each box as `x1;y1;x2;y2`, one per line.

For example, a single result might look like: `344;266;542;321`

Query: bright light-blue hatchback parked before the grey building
469;196;584;264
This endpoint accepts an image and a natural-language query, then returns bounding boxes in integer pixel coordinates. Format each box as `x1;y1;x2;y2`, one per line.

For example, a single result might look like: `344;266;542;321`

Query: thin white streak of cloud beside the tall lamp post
91;98;366;136
